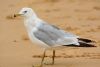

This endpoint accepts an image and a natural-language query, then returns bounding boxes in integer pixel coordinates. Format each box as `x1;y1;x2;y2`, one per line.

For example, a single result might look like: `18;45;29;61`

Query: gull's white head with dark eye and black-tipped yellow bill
14;8;36;18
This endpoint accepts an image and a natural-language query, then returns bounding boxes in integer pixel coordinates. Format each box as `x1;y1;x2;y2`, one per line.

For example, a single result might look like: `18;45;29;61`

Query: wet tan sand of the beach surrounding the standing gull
0;0;100;67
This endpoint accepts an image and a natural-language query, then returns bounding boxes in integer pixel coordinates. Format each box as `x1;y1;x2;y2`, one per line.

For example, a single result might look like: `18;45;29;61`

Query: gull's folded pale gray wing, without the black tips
33;23;78;46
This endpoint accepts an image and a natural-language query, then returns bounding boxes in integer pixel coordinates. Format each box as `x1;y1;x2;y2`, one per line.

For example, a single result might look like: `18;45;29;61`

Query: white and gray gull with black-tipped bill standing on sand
14;8;95;67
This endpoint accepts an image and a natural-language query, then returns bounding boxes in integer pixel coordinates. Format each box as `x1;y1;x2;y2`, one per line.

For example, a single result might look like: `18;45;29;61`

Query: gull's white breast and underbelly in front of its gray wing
24;20;49;48
